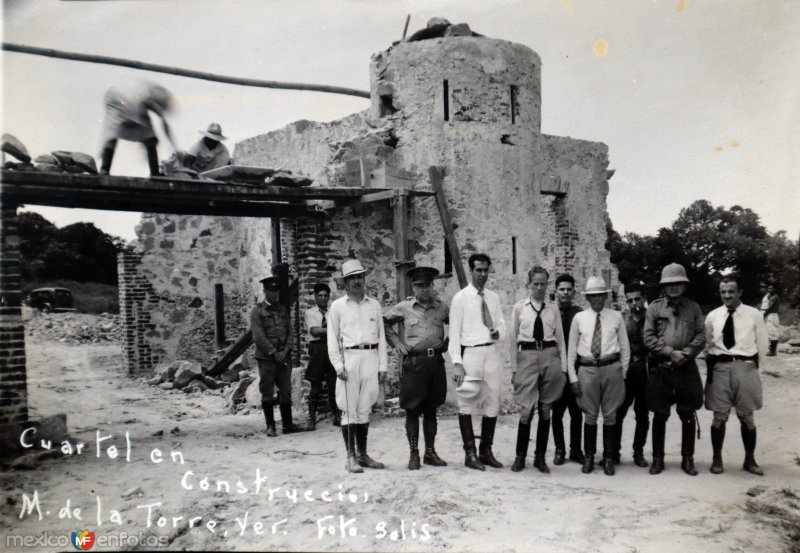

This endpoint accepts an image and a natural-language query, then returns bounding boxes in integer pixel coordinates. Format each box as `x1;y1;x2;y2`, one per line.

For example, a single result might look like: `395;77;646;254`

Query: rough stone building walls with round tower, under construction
125;37;617;410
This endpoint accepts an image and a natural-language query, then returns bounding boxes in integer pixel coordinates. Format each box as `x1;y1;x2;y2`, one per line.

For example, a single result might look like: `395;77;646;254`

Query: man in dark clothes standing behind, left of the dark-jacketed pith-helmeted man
614;280;650;467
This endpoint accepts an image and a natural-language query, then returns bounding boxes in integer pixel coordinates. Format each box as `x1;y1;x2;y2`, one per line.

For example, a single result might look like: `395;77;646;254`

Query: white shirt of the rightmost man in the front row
706;303;769;363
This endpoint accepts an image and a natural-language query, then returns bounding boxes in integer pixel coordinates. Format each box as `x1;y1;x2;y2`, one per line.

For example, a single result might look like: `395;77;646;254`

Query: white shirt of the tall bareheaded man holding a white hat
447;283;506;363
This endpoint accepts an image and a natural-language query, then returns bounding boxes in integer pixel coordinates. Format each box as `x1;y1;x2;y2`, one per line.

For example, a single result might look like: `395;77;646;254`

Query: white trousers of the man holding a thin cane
336;349;379;424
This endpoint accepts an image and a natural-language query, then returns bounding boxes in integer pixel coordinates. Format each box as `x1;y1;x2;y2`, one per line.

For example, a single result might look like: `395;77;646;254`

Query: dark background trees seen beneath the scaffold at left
17;212;126;286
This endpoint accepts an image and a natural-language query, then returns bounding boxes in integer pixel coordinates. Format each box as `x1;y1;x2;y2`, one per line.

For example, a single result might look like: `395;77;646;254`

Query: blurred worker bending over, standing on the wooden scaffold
100;82;178;176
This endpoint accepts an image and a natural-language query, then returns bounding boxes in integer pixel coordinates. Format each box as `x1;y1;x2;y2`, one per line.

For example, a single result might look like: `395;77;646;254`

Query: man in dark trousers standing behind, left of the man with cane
305;282;342;430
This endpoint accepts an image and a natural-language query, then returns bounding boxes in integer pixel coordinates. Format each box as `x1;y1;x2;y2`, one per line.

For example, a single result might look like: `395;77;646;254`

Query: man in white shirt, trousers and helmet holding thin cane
328;259;387;473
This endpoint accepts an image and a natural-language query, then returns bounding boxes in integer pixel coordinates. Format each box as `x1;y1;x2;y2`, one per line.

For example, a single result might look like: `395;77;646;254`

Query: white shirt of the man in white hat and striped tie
567;307;631;382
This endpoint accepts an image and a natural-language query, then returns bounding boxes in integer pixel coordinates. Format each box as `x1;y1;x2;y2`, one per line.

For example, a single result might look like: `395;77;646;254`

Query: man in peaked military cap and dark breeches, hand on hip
383;267;450;470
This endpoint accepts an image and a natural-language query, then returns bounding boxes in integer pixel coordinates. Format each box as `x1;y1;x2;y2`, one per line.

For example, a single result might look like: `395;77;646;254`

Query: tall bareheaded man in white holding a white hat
448;253;506;470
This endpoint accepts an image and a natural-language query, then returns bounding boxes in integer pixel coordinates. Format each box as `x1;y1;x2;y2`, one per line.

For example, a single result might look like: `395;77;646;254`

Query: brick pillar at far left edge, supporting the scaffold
0;205;28;424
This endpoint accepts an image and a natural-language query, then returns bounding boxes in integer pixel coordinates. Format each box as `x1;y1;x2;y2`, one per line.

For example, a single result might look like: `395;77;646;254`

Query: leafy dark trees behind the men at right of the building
606;200;800;310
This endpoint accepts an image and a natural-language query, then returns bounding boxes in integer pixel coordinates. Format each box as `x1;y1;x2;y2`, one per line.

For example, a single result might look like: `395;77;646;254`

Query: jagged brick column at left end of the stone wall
117;252;159;376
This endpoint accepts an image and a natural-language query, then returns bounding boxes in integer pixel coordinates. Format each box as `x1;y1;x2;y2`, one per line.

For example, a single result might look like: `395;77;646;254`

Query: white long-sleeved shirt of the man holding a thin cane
328;295;388;374
